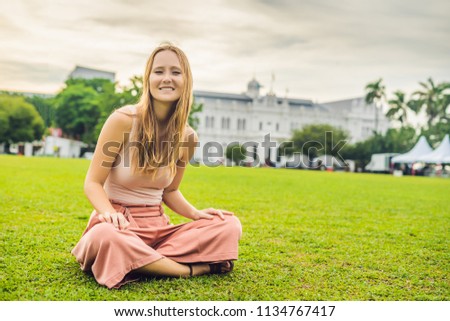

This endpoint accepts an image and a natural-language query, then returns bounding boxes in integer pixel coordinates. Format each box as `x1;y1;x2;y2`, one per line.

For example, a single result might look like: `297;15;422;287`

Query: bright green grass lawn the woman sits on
0;156;450;301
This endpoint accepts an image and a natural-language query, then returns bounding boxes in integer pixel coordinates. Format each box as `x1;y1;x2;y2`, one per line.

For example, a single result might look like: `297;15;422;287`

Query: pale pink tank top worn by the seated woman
104;106;172;205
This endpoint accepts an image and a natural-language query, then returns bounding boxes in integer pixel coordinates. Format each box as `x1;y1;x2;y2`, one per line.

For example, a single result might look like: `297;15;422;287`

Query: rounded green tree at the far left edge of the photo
0;94;45;152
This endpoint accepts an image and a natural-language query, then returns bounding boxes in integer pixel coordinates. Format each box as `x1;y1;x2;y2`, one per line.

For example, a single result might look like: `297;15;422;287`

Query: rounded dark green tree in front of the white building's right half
279;124;348;160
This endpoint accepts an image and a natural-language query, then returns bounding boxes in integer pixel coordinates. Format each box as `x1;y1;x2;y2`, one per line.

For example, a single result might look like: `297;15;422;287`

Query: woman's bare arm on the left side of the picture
84;111;132;227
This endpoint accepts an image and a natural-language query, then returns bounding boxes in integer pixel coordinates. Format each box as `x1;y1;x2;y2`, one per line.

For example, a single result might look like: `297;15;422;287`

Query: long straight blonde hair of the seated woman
131;43;193;177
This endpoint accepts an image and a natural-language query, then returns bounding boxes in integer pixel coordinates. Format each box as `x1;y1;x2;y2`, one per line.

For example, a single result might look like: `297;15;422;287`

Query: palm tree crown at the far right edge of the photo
409;78;450;127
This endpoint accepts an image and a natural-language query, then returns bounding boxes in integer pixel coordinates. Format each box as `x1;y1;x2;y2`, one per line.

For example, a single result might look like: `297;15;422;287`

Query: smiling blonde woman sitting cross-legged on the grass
72;44;242;288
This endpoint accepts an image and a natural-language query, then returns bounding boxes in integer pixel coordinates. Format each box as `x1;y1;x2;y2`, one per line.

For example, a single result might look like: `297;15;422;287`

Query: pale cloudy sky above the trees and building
0;0;450;102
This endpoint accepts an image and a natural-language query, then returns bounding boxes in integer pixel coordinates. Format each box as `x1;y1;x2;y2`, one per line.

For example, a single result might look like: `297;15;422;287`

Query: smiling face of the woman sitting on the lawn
149;50;184;103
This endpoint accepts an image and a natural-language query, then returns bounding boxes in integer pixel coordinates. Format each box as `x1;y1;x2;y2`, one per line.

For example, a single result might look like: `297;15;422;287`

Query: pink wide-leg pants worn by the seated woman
72;203;242;288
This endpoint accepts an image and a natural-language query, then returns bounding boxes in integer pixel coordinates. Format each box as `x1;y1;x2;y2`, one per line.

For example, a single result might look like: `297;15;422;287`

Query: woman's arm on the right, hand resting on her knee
163;127;233;220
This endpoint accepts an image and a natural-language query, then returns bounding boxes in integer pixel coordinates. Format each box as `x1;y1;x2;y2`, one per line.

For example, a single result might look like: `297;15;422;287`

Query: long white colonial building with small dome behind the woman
194;79;390;163
